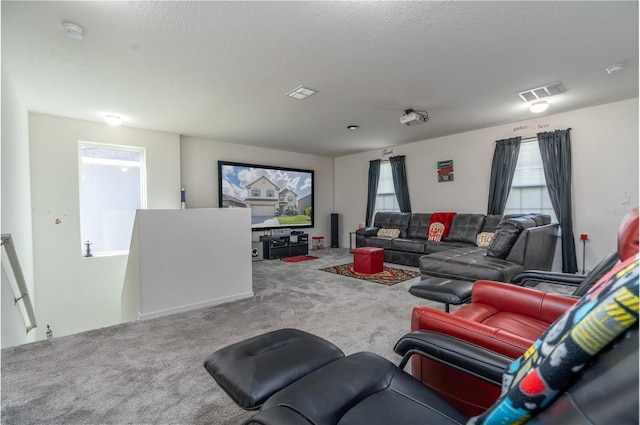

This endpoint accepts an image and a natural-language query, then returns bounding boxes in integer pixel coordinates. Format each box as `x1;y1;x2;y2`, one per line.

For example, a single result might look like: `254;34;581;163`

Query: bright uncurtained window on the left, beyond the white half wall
79;142;147;256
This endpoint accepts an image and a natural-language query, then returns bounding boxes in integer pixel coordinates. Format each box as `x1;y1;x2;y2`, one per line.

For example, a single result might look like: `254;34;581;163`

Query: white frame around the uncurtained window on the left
78;140;147;258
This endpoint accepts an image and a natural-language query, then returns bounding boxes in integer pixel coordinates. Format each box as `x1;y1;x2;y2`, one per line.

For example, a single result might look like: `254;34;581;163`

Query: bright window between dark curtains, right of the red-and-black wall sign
504;138;557;221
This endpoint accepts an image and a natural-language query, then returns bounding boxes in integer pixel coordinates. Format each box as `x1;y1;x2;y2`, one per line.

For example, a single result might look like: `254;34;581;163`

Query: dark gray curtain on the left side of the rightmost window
487;137;522;215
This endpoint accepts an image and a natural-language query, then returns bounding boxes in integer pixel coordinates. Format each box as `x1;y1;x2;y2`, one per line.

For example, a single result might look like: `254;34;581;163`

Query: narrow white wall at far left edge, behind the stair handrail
1;70;36;347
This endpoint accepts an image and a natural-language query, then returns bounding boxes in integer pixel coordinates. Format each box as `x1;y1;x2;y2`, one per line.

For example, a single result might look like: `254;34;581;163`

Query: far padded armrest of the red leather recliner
471;280;576;323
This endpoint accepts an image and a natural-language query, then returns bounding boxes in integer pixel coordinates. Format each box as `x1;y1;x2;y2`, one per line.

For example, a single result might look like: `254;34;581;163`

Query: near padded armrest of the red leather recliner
411;307;533;358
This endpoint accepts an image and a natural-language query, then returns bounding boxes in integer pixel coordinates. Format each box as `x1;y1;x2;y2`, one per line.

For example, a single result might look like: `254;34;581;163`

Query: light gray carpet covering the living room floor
1;249;442;425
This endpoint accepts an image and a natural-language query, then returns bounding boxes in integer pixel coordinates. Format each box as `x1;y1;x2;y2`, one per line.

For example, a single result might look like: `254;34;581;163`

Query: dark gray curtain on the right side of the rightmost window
537;128;578;273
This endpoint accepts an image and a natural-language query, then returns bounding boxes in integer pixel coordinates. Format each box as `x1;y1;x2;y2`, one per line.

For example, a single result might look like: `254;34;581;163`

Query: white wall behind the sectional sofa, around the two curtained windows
335;98;638;270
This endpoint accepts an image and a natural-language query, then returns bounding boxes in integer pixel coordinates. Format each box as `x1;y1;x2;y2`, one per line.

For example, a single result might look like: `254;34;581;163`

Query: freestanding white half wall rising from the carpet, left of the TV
122;208;253;321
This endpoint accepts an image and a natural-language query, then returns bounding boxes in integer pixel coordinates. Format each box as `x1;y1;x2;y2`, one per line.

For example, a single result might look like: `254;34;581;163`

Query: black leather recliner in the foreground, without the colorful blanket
205;325;638;425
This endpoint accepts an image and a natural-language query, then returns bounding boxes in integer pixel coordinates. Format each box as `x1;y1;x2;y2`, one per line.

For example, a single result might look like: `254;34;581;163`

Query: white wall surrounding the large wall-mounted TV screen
180;136;334;242
